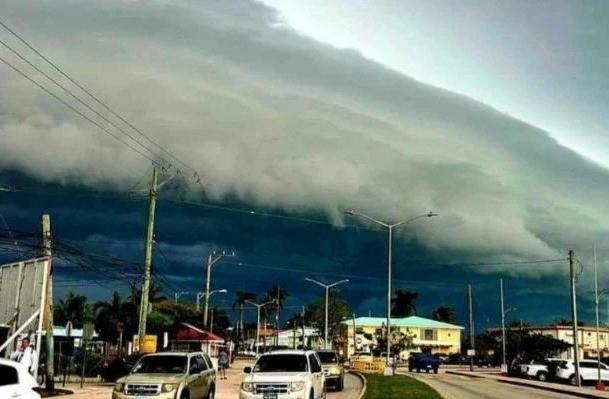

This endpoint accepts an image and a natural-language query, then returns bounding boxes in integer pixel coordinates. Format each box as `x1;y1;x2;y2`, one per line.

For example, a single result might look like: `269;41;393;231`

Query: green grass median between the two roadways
364;374;442;399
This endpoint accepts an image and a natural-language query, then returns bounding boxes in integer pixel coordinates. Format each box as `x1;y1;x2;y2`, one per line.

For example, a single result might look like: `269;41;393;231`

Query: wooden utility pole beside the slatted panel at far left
41;214;55;392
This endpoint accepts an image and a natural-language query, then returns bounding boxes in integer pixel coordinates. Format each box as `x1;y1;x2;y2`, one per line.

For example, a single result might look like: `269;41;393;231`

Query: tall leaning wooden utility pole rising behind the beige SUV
137;165;158;352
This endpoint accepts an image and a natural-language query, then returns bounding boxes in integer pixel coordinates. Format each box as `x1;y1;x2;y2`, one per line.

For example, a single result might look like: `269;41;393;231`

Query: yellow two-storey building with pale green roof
342;316;463;356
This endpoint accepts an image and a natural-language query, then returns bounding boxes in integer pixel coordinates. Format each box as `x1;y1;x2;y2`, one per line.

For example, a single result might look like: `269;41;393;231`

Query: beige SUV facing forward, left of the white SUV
112;352;216;399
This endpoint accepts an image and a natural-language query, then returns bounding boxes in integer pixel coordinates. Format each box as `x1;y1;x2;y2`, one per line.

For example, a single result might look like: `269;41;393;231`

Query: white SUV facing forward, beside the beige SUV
239;350;326;399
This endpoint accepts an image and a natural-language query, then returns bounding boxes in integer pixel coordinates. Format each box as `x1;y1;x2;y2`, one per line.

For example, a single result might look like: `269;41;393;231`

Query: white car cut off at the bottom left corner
0;359;40;399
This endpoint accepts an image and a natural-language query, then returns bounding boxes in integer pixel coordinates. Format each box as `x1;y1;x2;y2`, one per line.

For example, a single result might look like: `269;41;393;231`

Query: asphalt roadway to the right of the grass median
414;372;573;399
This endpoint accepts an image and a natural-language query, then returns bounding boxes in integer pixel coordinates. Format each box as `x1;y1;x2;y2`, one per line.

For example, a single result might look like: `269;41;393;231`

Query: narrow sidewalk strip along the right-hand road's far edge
445;370;609;399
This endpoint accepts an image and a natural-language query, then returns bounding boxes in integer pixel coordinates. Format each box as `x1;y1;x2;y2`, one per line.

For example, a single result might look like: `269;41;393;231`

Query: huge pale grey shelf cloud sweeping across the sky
0;0;609;274
